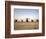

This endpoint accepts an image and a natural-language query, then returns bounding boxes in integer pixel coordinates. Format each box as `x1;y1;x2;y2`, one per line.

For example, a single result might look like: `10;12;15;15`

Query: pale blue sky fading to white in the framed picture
14;8;39;20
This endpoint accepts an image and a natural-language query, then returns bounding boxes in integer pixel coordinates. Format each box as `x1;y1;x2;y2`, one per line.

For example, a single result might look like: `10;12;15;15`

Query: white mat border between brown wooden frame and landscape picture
11;5;42;34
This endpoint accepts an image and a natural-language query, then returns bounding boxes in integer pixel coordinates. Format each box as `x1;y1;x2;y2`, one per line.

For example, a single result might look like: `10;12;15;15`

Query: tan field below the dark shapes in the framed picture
14;22;38;30
